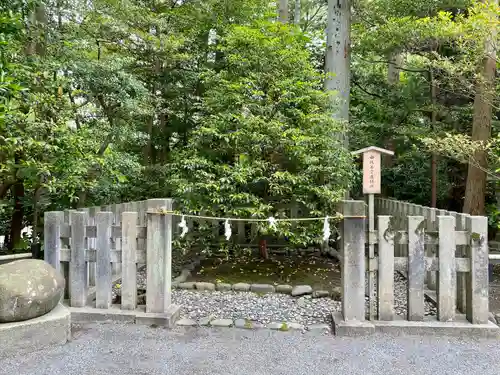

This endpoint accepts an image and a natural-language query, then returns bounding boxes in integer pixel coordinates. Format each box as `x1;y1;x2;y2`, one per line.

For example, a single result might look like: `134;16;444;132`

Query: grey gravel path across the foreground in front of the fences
0;324;500;375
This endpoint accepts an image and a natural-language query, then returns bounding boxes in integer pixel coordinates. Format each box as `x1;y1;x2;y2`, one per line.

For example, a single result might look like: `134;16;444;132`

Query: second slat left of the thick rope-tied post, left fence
95;212;113;309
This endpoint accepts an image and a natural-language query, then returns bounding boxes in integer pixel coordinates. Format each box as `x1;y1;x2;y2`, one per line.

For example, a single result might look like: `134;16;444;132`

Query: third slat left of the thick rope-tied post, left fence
69;211;87;307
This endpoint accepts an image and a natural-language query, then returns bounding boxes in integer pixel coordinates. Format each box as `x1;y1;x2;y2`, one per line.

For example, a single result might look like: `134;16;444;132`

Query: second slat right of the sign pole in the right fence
408;216;425;321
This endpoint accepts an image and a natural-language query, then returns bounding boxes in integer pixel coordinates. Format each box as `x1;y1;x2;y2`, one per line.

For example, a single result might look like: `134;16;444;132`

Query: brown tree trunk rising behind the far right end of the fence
463;0;498;215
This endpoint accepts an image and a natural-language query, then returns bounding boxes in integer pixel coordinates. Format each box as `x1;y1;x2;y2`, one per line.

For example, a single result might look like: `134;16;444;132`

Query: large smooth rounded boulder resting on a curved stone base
0;259;64;323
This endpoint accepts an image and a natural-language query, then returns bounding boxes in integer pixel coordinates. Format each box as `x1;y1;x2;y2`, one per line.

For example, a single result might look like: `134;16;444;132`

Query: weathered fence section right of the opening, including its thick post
337;200;489;336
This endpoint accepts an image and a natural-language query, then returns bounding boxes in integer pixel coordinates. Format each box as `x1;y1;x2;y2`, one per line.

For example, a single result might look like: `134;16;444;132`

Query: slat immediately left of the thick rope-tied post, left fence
121;212;138;310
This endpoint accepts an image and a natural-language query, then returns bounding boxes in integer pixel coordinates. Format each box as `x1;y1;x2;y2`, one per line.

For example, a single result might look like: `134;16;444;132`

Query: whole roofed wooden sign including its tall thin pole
352;146;394;320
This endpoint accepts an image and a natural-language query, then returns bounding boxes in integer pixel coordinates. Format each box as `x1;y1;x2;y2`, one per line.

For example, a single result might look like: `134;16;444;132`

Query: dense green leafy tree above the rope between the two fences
171;22;354;247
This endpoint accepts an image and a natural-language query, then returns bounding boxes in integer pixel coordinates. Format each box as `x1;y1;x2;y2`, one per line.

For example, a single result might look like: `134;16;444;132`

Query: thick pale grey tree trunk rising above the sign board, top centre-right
325;0;351;148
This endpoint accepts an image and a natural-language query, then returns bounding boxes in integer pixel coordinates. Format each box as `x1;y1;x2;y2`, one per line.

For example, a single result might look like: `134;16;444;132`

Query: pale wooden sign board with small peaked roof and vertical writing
353;146;394;194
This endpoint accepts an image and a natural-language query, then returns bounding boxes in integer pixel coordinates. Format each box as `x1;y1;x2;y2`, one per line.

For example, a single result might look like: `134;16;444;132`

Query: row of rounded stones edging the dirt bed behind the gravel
172;257;341;301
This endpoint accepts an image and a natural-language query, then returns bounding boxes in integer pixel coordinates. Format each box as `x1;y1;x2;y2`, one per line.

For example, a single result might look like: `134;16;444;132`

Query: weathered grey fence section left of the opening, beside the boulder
44;199;320;313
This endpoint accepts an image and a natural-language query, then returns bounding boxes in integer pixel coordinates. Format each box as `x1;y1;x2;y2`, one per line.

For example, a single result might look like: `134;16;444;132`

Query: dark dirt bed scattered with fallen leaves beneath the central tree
188;254;340;291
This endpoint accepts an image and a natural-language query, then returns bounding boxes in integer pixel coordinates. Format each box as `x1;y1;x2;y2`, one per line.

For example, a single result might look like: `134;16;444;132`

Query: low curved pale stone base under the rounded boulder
0;304;71;359
